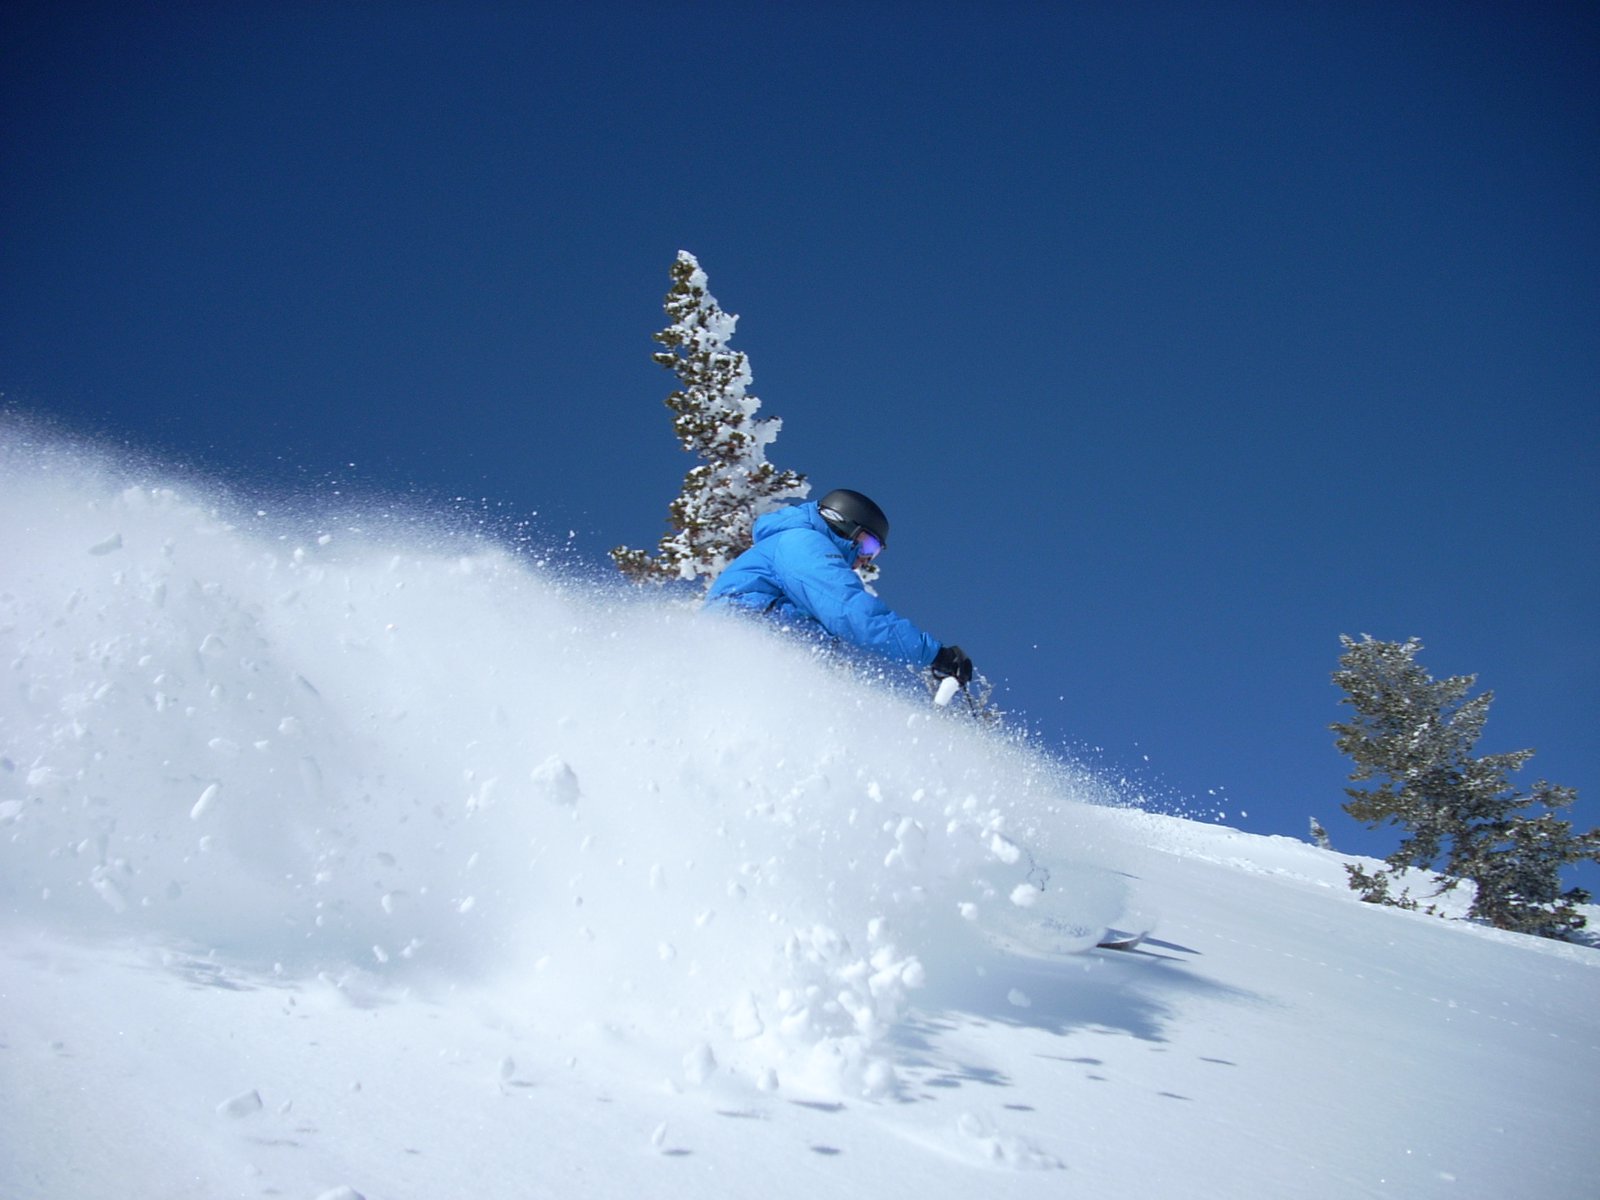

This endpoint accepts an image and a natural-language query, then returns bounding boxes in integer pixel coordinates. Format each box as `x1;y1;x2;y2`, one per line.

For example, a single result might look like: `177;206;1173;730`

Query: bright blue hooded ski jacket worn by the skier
706;501;939;667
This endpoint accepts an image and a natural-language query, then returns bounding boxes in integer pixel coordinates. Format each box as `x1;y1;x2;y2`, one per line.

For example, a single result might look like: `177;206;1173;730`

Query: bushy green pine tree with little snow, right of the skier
1333;635;1600;938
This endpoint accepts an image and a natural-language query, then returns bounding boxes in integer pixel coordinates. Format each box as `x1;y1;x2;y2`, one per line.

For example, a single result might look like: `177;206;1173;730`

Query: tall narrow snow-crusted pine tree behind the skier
611;250;810;586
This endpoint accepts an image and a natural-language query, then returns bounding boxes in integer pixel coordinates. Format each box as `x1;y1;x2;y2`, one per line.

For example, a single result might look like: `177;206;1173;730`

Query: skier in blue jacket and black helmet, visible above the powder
706;488;973;688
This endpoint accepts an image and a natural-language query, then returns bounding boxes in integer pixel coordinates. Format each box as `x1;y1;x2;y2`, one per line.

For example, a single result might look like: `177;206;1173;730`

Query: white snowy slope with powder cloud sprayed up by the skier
0;441;1600;1200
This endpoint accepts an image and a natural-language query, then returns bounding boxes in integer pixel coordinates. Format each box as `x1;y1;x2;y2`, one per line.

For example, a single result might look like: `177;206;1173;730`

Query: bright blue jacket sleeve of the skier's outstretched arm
773;530;939;667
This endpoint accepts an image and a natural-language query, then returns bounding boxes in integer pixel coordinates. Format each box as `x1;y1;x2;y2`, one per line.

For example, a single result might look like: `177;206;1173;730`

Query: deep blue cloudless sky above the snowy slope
0;0;1600;882
